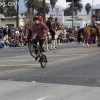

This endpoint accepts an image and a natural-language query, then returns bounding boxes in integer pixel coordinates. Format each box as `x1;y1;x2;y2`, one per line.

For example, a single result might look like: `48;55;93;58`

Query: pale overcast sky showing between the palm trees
46;0;100;8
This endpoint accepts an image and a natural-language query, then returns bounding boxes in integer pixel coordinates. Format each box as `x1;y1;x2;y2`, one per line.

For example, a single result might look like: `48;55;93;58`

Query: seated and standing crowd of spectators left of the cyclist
0;26;27;48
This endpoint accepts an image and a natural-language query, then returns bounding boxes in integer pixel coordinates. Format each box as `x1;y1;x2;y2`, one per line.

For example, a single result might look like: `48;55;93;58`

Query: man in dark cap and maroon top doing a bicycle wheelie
32;17;49;52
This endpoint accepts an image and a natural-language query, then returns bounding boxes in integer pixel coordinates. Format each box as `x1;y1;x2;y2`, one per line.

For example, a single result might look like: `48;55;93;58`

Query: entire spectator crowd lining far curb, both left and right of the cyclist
0;26;77;48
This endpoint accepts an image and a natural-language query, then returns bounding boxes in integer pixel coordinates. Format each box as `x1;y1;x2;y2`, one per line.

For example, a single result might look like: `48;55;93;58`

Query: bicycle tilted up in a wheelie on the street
29;38;47;68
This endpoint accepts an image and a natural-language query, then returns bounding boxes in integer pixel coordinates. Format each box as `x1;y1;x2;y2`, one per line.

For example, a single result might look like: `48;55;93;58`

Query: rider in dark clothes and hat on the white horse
46;17;55;39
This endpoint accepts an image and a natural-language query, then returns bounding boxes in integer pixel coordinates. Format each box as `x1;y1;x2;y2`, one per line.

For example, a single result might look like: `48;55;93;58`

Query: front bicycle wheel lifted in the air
29;44;38;58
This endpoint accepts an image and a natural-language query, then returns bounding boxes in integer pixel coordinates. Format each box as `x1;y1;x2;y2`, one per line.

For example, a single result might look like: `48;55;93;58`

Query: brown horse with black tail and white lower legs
77;26;100;48
